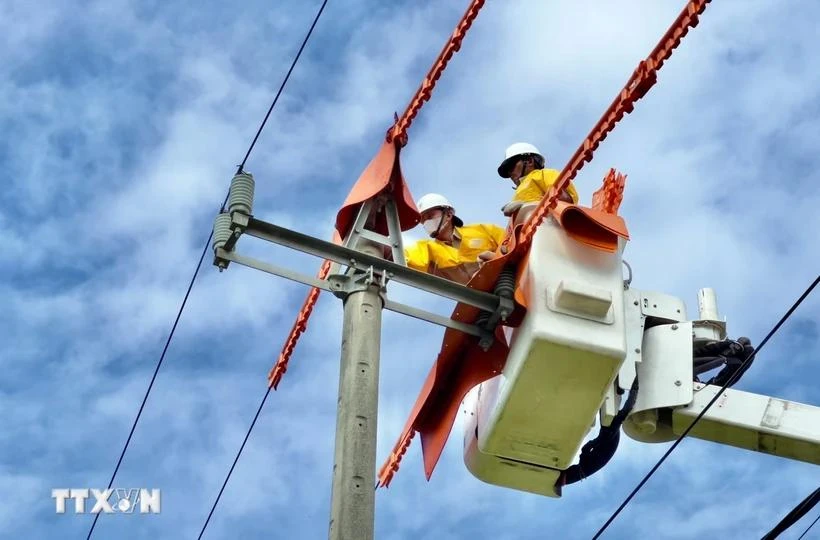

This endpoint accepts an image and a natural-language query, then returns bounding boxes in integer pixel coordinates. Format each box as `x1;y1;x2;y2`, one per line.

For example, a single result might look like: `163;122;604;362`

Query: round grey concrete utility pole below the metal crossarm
329;271;383;540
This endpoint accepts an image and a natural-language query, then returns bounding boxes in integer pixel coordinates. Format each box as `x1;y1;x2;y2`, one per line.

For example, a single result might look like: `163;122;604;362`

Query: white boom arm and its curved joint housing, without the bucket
624;310;820;464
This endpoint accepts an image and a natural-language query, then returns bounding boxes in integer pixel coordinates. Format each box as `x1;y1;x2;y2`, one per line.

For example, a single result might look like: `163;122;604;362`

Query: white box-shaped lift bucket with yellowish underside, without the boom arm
465;215;627;476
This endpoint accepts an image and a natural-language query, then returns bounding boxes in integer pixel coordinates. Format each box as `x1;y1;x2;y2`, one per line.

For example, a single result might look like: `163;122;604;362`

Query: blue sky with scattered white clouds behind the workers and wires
0;0;820;539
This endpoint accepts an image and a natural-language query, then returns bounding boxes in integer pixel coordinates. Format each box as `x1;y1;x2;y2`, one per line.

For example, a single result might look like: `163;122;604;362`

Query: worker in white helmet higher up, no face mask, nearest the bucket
498;143;578;216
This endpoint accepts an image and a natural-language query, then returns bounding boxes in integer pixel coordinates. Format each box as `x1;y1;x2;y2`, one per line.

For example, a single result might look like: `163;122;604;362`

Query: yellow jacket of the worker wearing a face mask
404;224;506;285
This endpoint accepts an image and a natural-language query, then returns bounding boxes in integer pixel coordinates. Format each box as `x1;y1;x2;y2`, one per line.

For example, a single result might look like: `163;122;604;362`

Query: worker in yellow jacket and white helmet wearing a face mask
404;193;505;285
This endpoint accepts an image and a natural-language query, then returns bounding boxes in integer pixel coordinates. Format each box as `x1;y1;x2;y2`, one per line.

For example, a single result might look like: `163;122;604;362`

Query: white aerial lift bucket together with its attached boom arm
462;228;820;497
